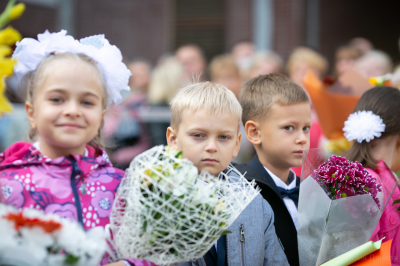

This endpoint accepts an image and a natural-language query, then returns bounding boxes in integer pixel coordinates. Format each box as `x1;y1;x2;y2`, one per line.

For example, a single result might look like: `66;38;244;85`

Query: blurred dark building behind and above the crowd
4;0;400;68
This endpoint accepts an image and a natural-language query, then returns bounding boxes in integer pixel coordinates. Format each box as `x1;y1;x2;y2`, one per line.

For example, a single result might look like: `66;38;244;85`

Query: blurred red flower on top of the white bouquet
3;213;61;233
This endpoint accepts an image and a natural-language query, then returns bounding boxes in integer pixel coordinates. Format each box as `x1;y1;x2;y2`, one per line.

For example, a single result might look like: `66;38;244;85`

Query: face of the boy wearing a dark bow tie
250;102;312;170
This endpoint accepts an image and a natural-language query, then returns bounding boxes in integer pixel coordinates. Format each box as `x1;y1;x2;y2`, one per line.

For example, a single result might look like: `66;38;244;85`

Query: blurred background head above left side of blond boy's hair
175;44;207;81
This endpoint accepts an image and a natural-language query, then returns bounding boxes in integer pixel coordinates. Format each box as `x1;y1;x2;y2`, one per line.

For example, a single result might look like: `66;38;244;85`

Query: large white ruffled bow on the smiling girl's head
12;30;131;105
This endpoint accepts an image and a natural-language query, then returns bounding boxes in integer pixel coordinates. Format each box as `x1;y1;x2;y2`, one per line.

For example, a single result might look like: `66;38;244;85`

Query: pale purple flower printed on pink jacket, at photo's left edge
0;179;25;208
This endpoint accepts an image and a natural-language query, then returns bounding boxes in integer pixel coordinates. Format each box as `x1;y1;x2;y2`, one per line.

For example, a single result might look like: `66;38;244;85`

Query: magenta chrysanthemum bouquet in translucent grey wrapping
297;149;395;266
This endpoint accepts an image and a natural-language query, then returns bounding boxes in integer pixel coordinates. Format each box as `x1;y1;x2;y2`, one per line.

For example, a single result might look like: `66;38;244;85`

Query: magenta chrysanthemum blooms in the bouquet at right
313;155;382;208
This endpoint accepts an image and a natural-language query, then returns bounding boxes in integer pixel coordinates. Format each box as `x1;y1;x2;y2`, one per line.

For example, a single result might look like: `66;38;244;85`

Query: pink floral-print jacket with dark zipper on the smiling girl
0;142;154;266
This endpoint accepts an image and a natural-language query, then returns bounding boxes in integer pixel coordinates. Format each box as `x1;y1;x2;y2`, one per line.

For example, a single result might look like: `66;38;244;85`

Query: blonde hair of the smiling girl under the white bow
21;53;108;153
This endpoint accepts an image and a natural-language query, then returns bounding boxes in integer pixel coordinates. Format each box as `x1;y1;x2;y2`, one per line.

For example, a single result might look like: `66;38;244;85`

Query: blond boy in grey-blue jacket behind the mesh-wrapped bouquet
167;82;288;266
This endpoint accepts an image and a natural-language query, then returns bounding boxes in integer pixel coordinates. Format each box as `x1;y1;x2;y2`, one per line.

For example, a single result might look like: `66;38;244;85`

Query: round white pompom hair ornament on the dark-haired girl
343;111;385;143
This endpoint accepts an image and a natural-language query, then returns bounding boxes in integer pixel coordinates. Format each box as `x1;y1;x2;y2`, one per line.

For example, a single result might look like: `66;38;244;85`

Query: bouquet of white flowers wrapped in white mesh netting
111;146;259;265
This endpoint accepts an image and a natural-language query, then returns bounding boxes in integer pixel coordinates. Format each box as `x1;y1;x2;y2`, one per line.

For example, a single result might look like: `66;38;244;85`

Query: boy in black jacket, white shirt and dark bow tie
236;73;311;266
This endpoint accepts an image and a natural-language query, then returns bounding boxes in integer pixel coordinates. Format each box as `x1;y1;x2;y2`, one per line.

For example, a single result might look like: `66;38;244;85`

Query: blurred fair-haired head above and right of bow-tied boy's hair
286;47;328;87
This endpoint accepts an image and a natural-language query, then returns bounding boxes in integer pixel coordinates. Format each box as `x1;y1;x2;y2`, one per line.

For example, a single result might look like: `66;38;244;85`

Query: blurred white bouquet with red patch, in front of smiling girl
0;203;106;266
